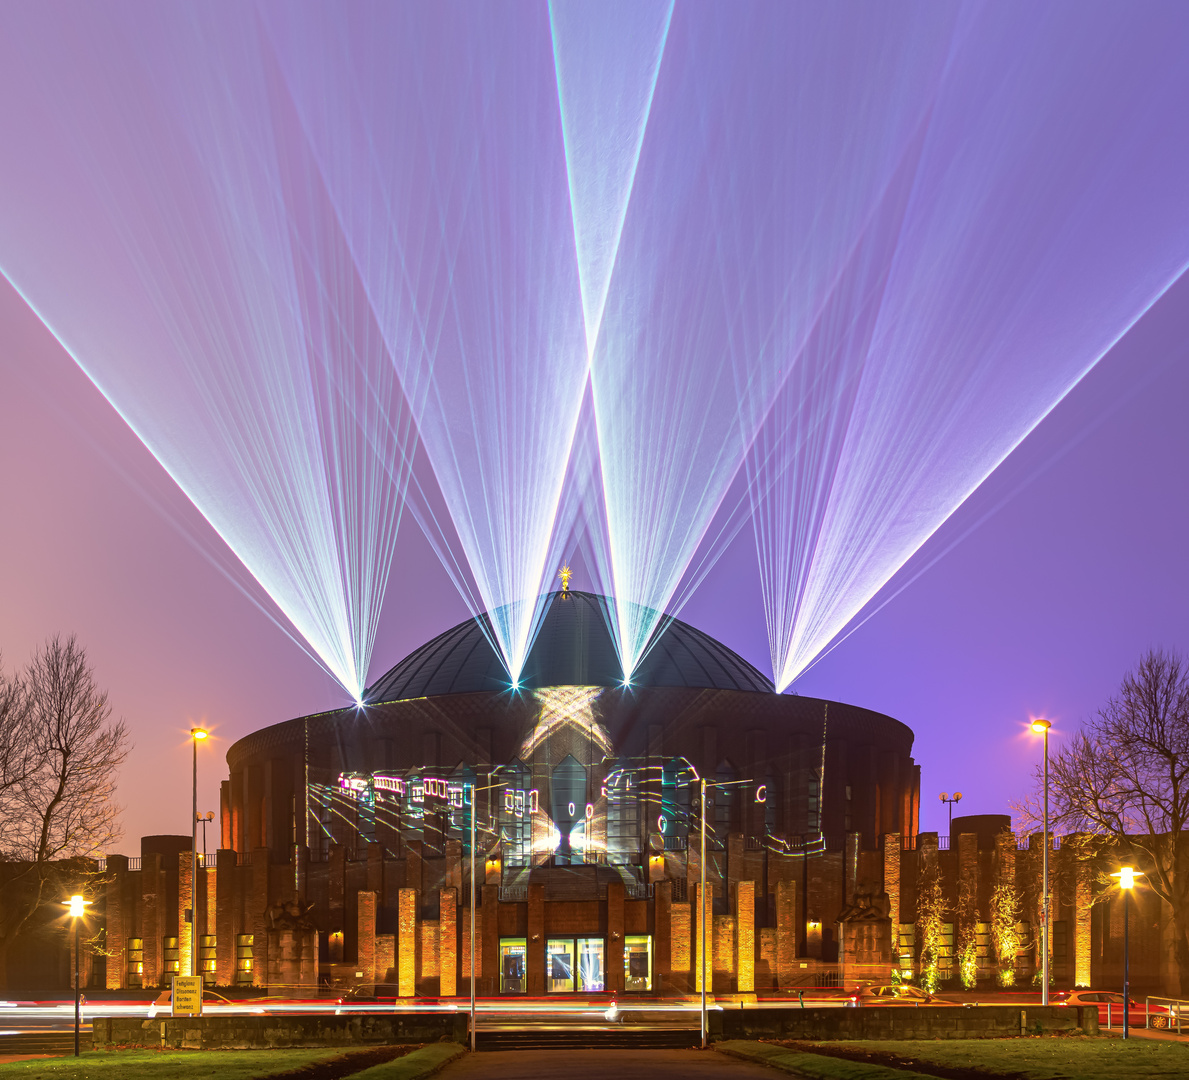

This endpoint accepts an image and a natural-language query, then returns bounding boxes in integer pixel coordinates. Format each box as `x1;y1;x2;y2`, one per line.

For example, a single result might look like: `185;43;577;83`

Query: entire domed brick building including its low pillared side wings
87;591;1136;1000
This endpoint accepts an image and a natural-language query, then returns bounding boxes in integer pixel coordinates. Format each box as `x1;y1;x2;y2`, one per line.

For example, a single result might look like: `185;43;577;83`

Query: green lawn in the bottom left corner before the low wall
0;1048;347;1080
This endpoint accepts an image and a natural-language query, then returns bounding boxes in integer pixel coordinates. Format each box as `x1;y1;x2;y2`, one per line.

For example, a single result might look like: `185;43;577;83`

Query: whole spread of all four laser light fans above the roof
0;0;1189;689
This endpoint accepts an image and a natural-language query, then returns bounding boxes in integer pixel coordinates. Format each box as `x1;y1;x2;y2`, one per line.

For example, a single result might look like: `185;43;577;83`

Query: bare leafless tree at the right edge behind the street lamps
1018;651;1189;994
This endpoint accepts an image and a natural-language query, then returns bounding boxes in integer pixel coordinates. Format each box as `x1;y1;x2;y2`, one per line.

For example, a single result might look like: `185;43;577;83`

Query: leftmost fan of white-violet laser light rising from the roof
0;4;413;698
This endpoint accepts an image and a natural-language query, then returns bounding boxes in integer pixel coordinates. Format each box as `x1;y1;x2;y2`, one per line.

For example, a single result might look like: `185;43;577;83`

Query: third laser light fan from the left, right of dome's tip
589;4;955;678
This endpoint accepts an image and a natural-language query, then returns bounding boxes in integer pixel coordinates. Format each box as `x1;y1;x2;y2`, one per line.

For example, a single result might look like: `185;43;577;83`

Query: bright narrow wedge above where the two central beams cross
549;0;673;363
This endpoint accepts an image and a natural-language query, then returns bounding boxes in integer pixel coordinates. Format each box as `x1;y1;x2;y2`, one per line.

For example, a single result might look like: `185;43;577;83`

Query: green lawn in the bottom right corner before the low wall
829;1037;1189;1080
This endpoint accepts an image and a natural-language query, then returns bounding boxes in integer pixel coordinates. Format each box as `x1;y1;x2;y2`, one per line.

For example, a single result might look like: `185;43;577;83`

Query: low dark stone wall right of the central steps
710;1005;1099;1040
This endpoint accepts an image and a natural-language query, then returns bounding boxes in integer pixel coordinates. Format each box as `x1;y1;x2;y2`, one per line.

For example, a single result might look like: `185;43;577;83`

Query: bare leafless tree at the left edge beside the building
0;636;128;987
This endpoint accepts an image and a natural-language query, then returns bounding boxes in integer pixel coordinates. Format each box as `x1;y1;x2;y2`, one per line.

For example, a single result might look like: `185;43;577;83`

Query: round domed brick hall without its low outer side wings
207;591;919;996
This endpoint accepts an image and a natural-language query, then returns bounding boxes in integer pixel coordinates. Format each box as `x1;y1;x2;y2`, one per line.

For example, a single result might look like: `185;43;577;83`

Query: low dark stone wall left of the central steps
92;1012;467;1050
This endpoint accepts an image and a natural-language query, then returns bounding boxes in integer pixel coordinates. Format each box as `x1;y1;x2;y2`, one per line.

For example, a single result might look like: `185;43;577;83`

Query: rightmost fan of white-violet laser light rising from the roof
756;5;1189;690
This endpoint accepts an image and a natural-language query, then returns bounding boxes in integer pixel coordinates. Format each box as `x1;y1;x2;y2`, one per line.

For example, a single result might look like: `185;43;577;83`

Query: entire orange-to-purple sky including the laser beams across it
0;2;1189;853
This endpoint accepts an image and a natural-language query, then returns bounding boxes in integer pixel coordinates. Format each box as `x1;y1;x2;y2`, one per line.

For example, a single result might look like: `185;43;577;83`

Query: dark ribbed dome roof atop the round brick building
364;591;774;704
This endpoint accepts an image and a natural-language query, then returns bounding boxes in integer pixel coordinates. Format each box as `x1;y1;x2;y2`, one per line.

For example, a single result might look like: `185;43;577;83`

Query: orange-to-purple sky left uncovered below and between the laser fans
0;259;1189;853
